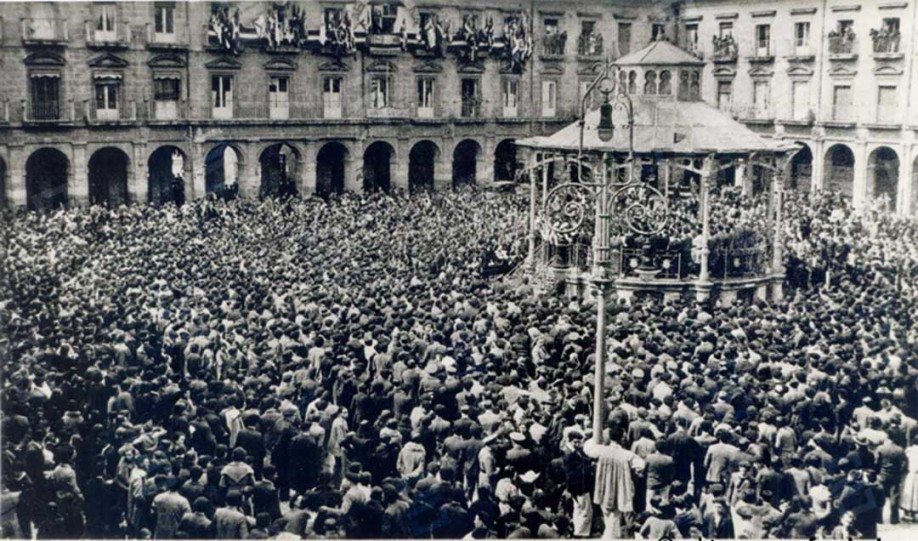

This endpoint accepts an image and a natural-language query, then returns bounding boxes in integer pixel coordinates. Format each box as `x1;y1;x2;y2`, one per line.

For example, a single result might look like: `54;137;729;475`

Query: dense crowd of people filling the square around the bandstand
0;187;918;539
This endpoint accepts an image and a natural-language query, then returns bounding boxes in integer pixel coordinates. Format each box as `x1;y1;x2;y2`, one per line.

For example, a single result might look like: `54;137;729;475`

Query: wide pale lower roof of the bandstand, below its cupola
517;96;786;155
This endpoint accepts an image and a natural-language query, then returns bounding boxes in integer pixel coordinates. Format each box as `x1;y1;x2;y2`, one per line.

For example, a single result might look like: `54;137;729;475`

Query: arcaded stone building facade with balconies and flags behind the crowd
0;0;918;214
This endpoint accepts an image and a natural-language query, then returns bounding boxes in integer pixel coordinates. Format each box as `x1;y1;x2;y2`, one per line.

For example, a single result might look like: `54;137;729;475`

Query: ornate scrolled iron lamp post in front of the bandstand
543;60;668;443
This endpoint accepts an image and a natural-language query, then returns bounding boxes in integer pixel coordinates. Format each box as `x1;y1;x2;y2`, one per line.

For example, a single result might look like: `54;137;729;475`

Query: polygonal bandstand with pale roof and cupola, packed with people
517;41;798;302
